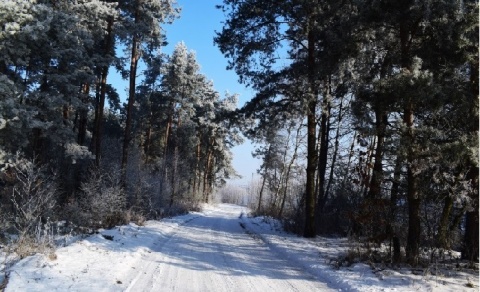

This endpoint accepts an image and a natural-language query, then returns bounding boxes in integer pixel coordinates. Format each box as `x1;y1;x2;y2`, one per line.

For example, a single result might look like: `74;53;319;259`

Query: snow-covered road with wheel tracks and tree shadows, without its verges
127;205;334;292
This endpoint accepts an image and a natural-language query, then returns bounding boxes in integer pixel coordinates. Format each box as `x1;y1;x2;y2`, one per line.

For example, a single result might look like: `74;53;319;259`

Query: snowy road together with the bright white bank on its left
6;205;332;292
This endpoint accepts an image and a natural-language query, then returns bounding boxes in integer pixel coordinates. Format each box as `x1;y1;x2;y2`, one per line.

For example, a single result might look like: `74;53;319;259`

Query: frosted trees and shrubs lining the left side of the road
0;0;241;252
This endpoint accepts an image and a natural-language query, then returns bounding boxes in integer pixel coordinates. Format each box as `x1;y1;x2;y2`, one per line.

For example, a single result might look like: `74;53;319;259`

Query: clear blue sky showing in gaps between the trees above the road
110;0;260;185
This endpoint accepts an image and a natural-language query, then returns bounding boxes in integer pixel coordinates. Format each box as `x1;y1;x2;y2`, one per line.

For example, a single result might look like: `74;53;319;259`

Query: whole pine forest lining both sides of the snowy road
0;0;479;265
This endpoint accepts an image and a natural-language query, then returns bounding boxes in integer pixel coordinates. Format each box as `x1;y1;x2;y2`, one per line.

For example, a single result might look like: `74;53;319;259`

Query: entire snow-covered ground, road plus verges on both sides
0;204;479;292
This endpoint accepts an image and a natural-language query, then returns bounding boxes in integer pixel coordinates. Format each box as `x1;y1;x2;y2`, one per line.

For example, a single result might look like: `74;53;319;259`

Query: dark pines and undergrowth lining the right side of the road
215;0;479;264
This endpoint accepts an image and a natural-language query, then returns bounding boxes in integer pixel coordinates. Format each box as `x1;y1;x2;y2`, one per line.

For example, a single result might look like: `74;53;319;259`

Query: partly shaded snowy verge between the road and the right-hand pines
242;211;479;292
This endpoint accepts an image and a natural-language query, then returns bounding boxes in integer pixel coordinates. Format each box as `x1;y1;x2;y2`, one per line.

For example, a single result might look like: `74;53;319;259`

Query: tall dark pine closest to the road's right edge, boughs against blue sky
215;0;355;237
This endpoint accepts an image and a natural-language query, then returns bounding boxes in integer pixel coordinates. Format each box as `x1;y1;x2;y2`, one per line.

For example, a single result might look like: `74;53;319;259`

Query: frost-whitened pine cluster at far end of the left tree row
134;43;238;206
